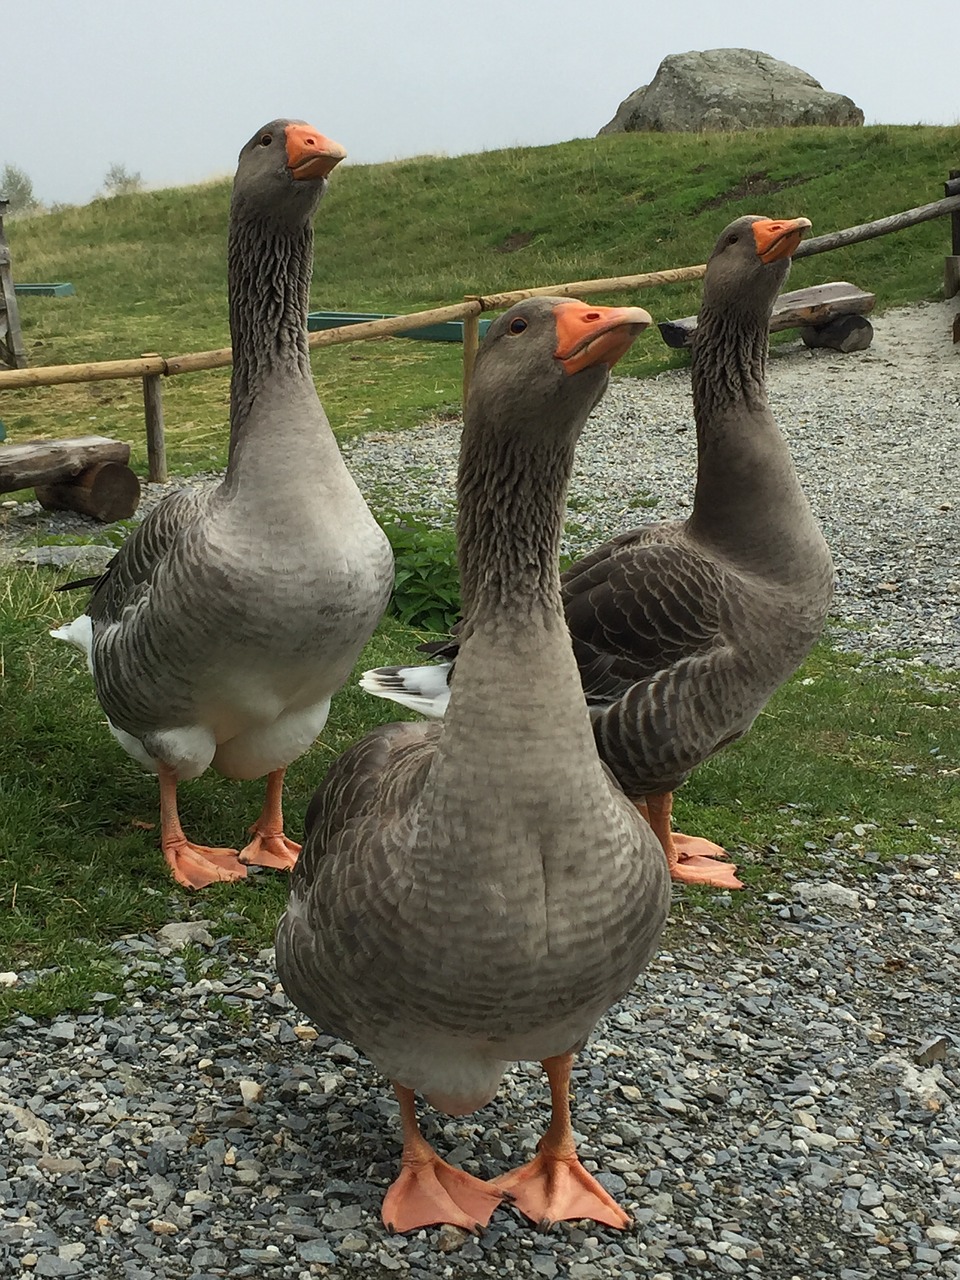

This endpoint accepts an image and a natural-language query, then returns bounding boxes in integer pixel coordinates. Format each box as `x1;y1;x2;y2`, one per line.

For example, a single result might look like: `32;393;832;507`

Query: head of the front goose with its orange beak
467;297;652;438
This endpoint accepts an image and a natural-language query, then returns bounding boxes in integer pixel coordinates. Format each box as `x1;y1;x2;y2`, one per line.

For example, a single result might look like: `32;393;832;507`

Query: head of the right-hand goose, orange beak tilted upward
703;214;813;314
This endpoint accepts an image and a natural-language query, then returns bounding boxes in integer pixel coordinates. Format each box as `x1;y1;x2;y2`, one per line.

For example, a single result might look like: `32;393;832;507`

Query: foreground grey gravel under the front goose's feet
0;833;960;1280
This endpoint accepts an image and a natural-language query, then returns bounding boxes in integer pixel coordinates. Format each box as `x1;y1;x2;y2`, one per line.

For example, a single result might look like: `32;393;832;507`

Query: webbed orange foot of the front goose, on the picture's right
492;1149;631;1230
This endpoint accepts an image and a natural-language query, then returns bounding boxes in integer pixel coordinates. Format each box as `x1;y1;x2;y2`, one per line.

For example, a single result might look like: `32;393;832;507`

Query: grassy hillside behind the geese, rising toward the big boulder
0;125;960;471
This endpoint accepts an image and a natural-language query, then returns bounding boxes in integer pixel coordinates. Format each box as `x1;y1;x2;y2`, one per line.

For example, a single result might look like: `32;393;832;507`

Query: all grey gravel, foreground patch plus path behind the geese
0;305;960;1280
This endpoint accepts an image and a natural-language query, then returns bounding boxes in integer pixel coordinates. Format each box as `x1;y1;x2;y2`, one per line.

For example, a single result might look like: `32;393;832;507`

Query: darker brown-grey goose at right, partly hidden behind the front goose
361;215;833;888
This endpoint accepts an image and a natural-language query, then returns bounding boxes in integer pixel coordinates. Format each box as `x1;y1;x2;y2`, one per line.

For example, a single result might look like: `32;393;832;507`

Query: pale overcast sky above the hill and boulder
7;0;960;204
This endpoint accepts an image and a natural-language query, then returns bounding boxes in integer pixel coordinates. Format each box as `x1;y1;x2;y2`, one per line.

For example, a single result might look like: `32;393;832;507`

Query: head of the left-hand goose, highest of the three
230;120;347;227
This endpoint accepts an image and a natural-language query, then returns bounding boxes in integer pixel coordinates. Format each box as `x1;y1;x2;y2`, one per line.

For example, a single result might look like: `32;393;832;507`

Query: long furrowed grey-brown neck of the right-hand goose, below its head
687;307;813;568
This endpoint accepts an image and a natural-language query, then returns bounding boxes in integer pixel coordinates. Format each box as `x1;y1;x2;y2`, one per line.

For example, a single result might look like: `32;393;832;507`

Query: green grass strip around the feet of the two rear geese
0;571;960;1021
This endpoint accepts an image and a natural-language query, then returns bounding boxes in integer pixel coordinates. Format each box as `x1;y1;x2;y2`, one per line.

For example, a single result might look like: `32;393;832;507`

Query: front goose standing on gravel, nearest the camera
276;297;669;1231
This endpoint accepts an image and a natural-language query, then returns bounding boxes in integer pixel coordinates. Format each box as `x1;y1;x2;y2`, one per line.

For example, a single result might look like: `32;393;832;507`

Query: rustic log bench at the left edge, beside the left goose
0;435;140;521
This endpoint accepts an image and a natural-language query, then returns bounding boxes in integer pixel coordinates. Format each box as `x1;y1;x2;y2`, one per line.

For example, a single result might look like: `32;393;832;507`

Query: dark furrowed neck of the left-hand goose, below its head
228;218;314;460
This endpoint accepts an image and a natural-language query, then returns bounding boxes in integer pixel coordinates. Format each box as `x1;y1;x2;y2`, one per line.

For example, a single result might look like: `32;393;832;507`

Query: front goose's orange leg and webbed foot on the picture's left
380;1080;504;1231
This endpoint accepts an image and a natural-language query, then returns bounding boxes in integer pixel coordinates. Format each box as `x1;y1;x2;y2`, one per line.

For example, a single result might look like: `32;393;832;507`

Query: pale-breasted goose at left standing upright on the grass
51;120;393;888
